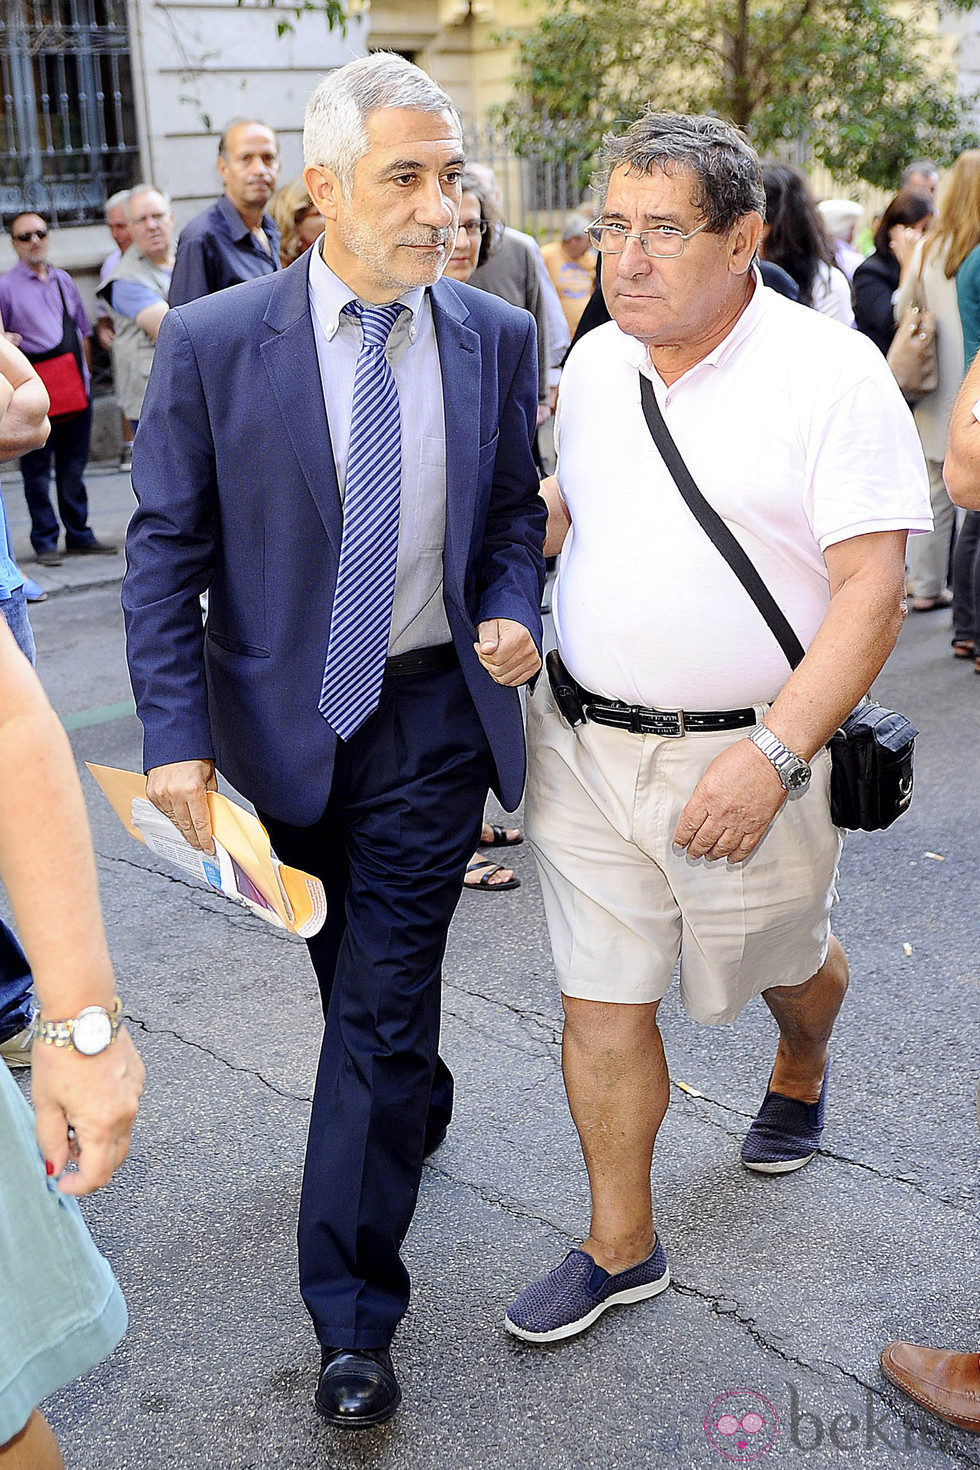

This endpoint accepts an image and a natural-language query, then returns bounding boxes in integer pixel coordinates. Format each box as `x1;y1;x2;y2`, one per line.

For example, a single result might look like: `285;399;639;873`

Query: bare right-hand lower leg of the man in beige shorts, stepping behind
763;935;849;1103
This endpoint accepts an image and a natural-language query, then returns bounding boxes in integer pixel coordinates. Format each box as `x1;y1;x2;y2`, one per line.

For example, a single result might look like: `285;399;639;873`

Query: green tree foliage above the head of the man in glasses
500;0;976;187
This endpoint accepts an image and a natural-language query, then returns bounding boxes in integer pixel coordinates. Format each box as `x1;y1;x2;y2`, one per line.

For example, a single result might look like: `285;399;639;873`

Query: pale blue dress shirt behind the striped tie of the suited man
310;244;451;654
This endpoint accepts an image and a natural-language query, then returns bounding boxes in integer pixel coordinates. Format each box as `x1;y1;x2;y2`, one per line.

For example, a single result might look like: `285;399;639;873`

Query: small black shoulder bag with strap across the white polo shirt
639;372;918;832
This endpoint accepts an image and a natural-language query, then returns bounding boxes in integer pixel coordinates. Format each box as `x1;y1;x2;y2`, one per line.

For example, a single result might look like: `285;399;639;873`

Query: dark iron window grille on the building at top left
0;0;138;225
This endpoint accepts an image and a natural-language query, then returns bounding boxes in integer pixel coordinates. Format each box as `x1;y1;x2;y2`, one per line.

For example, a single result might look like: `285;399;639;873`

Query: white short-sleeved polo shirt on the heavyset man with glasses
554;279;932;710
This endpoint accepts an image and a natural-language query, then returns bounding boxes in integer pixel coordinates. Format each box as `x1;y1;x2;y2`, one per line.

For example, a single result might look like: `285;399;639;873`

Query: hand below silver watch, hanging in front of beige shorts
674;739;786;863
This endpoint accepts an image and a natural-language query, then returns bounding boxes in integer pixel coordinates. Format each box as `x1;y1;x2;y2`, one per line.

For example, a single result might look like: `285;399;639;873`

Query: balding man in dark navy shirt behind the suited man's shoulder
170;118;279;306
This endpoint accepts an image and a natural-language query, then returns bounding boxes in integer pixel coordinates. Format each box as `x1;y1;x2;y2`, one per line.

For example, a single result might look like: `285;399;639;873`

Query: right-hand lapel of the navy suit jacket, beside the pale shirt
430;281;482;592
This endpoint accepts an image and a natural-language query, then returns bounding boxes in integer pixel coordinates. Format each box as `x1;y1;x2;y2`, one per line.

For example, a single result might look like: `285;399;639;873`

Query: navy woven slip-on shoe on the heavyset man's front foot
504;1241;670;1342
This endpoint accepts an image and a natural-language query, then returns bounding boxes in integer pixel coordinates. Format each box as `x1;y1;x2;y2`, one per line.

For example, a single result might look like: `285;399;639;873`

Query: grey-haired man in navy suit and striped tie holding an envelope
123;54;545;1427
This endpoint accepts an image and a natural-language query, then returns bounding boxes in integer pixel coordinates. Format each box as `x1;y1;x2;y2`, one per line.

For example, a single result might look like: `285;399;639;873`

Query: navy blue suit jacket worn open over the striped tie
122;256;545;826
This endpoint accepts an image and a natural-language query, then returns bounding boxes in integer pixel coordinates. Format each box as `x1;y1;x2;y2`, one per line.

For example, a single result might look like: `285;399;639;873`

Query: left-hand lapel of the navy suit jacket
260;251;344;557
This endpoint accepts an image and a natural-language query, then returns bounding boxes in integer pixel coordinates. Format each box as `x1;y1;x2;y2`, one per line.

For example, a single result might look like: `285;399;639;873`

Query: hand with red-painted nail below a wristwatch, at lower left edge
31;1017;145;1195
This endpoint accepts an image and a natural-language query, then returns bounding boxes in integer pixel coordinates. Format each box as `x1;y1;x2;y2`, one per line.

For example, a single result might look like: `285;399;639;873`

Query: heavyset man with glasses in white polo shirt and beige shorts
507;113;932;1342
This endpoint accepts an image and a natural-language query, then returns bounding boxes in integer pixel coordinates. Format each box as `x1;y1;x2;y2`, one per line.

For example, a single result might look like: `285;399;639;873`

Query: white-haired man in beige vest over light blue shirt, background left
98;184;173;431
